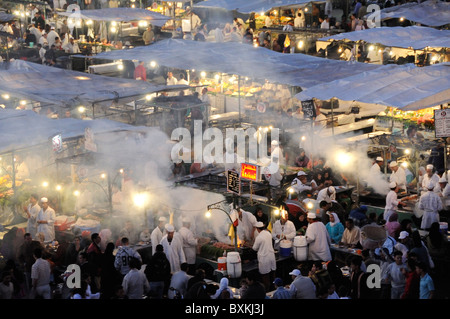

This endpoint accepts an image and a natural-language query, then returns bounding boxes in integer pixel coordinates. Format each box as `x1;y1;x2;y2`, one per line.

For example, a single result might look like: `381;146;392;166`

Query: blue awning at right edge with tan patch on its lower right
295;63;450;111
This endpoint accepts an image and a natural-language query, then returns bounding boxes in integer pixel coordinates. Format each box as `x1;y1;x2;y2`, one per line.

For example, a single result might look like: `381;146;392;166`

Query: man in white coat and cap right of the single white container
305;212;332;261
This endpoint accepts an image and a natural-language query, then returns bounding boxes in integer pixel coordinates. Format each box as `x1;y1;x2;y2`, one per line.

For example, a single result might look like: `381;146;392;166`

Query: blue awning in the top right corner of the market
366;0;450;27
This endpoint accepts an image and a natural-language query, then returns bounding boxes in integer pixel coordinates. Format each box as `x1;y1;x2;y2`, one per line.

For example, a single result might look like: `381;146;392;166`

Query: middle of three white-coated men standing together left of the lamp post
160;224;186;274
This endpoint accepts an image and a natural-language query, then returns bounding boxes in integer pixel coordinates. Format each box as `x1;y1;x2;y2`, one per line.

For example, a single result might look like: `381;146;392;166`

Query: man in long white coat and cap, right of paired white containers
252;222;277;291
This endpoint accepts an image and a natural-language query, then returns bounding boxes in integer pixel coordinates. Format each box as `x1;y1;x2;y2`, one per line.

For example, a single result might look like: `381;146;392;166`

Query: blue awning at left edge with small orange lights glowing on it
0;60;187;107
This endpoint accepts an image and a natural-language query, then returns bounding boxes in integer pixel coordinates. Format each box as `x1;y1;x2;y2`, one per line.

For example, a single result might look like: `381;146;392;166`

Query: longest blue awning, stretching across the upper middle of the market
96;39;380;88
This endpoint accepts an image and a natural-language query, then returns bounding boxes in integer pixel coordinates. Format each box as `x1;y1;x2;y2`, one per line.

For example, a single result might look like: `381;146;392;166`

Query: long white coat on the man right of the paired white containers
252;229;277;275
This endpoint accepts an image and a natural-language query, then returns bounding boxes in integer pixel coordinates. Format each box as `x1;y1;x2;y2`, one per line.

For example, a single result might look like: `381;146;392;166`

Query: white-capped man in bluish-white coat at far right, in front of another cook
419;181;444;230
